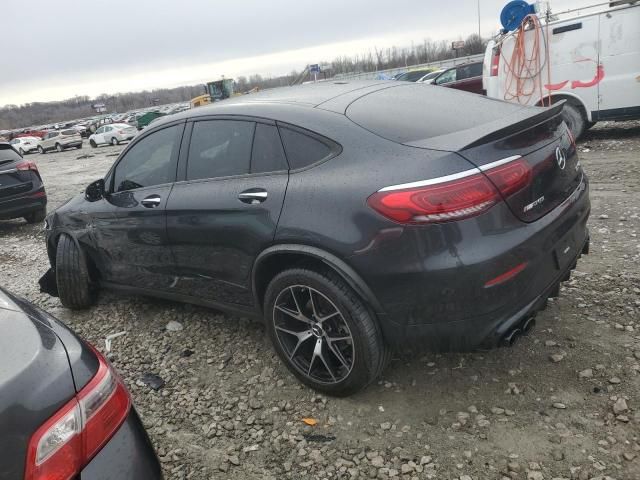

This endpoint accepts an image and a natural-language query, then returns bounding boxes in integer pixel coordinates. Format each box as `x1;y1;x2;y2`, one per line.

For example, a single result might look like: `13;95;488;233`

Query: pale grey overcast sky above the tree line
0;0;595;105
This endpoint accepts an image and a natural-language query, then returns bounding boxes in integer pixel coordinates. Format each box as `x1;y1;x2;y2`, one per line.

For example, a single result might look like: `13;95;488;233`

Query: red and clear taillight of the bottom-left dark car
24;349;131;480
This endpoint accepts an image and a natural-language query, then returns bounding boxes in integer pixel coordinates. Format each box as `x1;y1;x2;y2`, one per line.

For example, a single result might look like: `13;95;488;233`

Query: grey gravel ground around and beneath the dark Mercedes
0;122;640;480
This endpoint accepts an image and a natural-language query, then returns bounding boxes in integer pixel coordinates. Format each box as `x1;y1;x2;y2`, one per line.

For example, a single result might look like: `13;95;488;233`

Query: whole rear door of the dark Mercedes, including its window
167;118;289;306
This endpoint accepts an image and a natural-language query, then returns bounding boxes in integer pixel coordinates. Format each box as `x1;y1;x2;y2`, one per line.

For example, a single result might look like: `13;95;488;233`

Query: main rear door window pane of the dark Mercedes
187;120;255;180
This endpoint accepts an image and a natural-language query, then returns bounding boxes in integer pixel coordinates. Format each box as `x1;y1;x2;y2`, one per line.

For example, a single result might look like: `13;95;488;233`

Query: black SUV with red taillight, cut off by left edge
0;143;47;223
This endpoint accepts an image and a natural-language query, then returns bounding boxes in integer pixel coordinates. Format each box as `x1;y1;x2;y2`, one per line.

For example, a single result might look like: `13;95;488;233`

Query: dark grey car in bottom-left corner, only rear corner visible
0;288;162;480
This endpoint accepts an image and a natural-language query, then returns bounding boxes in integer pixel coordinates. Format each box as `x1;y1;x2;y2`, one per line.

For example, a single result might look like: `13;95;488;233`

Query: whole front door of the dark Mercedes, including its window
98;123;184;290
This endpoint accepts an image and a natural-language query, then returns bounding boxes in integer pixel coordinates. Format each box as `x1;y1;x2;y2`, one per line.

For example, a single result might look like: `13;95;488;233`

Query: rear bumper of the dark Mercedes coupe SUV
350;174;590;351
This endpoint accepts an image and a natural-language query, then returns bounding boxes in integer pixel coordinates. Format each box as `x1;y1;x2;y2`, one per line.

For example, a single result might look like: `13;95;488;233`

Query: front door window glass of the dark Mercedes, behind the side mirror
113;125;183;192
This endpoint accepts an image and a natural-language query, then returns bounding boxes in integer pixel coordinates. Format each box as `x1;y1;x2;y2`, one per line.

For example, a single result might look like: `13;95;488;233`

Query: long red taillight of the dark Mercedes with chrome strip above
367;157;531;224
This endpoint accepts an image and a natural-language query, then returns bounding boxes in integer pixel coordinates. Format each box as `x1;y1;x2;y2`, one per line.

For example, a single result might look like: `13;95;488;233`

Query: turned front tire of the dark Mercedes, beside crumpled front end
56;234;95;310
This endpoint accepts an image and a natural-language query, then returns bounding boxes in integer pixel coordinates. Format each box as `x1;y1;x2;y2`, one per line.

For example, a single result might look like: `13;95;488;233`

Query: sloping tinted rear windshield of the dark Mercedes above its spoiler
348;83;523;144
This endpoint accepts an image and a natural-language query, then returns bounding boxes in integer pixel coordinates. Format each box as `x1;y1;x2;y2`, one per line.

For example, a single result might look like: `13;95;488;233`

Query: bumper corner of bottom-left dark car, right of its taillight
80;408;162;480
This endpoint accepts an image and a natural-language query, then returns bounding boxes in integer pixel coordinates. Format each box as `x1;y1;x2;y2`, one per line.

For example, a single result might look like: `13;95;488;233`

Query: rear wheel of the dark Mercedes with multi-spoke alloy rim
264;268;389;397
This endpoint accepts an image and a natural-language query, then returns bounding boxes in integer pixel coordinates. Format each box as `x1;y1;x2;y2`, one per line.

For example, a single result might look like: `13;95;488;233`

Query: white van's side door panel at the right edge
598;5;640;120
